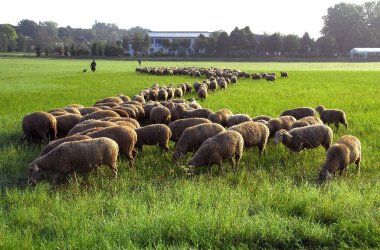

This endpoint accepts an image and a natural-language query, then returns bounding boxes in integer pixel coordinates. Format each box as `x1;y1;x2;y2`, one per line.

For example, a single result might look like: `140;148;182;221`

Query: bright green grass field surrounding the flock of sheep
0;59;380;249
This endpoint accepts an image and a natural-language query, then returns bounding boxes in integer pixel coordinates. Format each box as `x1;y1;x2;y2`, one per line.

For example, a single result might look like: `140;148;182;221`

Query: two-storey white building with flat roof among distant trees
148;31;211;55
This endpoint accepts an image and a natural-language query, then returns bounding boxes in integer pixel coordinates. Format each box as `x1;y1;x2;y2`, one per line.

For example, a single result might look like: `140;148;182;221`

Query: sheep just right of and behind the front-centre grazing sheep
228;121;269;156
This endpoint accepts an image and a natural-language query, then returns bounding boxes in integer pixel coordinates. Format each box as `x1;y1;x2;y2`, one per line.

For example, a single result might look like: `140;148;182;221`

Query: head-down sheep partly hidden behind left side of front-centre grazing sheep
173;123;225;160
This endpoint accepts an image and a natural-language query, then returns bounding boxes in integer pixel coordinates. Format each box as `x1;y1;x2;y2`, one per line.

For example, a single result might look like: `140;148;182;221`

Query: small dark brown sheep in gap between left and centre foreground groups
135;124;172;152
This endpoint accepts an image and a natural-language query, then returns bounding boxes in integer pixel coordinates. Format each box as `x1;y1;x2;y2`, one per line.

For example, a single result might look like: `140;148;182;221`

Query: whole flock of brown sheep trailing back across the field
22;68;361;184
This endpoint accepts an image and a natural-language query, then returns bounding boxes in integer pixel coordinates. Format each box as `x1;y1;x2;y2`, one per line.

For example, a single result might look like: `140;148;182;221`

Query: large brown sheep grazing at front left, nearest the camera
28;138;119;185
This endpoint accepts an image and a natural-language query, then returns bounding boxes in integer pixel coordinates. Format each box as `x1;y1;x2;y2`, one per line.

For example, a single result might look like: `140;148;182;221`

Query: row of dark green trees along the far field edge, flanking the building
0;1;380;57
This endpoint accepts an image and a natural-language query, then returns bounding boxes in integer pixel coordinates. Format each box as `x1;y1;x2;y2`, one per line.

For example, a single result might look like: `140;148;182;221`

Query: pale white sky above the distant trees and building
0;0;371;39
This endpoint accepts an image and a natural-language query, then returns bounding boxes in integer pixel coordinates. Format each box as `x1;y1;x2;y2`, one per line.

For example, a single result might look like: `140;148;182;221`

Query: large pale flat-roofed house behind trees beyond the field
148;31;211;55
